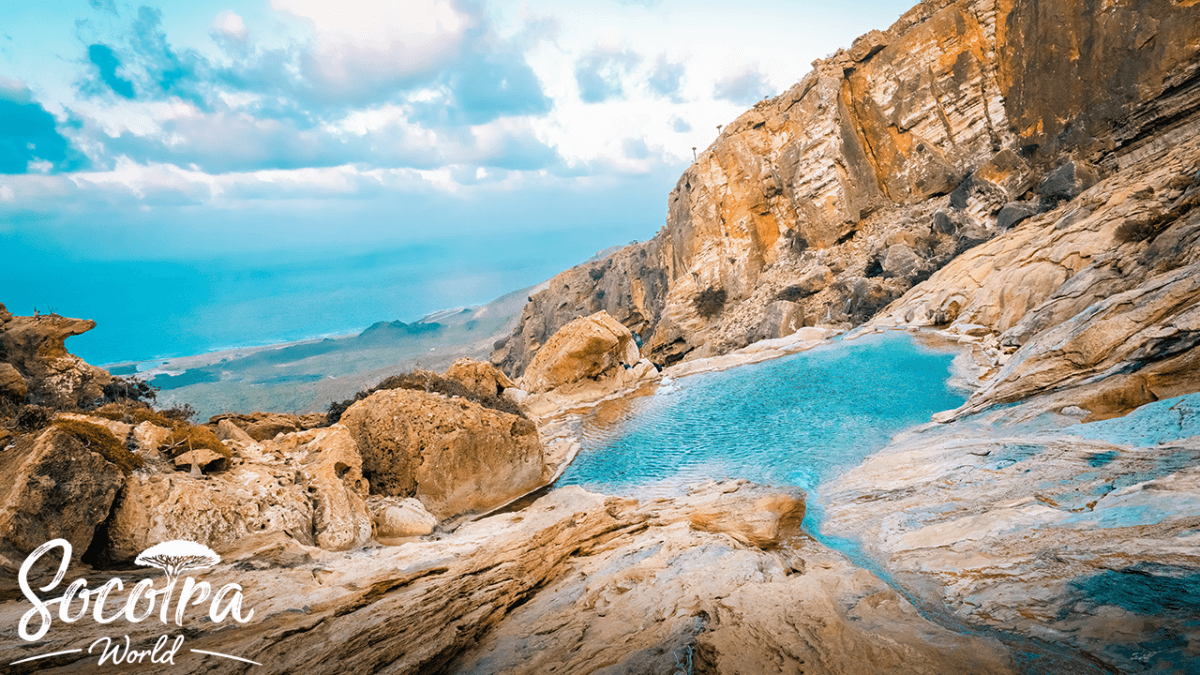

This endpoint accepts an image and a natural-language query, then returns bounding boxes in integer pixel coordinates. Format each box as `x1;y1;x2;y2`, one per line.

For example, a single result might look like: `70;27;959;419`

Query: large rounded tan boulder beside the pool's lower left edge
341;389;546;519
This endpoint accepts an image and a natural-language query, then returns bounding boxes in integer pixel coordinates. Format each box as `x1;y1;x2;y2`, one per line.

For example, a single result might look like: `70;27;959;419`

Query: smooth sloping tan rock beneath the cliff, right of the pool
872;129;1200;419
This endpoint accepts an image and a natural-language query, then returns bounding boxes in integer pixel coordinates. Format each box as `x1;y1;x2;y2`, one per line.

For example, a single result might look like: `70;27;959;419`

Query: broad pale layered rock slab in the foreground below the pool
0;485;1015;675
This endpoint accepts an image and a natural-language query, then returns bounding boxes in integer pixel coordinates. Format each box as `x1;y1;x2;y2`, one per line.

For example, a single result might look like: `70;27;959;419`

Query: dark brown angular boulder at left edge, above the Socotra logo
0;426;124;554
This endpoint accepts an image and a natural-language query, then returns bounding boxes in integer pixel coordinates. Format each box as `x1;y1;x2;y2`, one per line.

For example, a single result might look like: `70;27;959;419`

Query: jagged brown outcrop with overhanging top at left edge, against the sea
0;305;112;408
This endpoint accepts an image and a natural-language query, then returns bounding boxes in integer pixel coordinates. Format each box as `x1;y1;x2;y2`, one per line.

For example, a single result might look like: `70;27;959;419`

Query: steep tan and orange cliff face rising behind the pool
492;0;1200;376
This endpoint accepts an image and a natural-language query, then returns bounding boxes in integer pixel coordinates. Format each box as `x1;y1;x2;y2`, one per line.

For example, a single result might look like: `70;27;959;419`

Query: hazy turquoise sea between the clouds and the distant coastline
7;227;653;365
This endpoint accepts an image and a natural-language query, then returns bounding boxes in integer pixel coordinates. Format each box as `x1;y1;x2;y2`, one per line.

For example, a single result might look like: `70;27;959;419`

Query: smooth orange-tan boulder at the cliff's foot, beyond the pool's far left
522;311;640;393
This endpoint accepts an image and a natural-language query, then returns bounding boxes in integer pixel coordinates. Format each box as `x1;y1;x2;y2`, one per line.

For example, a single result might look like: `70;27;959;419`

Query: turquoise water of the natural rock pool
558;333;966;496
